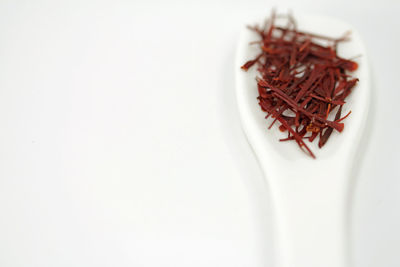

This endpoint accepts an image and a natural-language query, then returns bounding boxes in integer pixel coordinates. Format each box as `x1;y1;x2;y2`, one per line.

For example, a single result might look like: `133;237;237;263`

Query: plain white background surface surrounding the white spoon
0;0;400;267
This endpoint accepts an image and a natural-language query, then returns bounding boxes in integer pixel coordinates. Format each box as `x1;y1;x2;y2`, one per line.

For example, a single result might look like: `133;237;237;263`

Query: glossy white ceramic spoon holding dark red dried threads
235;15;370;267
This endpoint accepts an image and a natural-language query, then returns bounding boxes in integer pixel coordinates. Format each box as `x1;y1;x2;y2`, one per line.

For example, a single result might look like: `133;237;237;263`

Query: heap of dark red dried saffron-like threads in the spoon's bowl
241;12;358;158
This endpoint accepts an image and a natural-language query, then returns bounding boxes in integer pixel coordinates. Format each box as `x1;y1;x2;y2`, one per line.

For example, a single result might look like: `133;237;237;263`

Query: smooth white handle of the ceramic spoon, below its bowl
268;168;349;267
